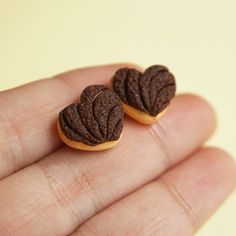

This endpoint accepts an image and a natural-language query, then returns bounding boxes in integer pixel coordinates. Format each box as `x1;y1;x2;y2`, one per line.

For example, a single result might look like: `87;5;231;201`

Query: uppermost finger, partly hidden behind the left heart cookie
0;64;131;179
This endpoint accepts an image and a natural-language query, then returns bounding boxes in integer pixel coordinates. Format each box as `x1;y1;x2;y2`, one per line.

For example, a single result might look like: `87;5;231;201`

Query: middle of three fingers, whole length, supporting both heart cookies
0;95;214;236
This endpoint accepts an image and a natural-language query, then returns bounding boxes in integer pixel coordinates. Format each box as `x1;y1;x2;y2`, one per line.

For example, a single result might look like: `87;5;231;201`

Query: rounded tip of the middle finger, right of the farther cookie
152;94;216;160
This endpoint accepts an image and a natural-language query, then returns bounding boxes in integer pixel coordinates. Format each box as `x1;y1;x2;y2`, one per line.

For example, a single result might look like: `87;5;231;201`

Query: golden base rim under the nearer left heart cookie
57;121;122;152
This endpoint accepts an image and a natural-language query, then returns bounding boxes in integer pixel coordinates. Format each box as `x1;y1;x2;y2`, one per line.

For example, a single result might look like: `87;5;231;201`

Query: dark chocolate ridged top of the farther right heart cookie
112;65;176;116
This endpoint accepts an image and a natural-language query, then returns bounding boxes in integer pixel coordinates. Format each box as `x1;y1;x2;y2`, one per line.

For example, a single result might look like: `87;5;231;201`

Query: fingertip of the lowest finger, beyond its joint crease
159;147;236;229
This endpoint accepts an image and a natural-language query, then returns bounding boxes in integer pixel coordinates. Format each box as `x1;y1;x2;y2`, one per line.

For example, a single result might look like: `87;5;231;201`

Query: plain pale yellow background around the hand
0;0;236;236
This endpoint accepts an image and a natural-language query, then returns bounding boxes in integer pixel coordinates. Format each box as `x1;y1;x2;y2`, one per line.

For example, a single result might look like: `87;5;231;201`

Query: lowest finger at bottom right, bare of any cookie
72;149;236;236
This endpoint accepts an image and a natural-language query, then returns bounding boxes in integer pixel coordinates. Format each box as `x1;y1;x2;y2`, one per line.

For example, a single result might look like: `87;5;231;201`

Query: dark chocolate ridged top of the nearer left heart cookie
59;85;124;146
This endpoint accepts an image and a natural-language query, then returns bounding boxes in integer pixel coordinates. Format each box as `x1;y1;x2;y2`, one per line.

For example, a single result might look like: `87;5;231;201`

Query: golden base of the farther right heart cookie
122;102;166;124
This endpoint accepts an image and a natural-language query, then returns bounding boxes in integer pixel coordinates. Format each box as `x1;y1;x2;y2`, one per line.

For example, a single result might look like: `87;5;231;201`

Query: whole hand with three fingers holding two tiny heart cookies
0;65;236;236
